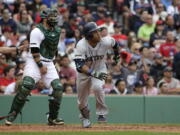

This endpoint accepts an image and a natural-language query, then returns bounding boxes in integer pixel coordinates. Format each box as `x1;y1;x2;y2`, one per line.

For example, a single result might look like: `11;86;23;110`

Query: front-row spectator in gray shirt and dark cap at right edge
157;67;180;94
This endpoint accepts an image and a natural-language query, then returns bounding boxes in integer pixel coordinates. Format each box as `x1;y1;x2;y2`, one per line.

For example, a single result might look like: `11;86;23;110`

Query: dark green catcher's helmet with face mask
40;8;58;27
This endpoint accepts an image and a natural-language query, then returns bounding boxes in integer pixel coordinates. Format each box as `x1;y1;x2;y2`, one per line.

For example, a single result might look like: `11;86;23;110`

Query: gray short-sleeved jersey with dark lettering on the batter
75;36;115;72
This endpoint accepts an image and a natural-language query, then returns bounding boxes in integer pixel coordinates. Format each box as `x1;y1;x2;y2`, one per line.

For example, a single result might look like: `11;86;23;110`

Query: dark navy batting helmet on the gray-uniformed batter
83;22;99;40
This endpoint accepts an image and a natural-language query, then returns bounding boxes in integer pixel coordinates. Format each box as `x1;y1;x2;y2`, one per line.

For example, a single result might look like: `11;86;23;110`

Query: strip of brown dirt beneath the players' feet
0;124;180;133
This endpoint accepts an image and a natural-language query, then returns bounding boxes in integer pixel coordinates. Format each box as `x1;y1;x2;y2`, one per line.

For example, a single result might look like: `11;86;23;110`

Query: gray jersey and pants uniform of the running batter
75;37;115;115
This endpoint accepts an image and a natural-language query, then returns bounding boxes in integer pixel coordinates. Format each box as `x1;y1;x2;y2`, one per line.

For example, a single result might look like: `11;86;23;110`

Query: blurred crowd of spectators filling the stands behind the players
0;0;180;96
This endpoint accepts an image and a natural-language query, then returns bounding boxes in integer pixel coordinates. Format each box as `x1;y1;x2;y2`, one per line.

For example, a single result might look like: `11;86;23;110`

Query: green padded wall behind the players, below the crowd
0;95;180;124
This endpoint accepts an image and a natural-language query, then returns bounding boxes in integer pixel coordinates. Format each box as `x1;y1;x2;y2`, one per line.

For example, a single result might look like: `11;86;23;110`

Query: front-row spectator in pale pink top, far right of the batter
143;77;158;96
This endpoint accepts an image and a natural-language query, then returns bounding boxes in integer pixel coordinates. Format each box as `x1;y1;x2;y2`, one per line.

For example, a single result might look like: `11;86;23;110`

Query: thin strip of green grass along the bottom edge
0;131;180;135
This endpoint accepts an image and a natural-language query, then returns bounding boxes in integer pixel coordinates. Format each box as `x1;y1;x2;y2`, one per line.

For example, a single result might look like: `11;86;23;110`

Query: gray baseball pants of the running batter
76;74;108;115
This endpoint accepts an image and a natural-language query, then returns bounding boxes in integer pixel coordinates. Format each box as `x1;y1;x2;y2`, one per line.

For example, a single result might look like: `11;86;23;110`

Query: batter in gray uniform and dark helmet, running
75;22;119;128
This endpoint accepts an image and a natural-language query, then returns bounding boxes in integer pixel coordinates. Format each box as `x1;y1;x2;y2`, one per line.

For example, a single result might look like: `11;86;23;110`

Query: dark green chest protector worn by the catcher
37;24;61;59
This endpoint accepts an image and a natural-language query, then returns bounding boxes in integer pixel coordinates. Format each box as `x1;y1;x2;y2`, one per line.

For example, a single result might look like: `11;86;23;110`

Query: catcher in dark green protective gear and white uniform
5;8;64;125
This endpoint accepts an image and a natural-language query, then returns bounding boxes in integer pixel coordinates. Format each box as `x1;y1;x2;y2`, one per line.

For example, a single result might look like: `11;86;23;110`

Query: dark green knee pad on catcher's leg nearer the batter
51;79;63;100
